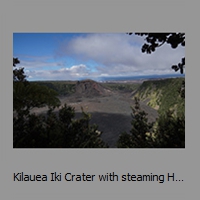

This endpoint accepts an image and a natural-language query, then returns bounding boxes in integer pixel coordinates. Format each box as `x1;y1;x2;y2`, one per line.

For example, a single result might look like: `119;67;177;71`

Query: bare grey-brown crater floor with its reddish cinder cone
32;80;157;148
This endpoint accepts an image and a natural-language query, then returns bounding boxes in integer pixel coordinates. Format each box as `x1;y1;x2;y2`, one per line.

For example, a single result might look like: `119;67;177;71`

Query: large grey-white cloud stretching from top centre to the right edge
57;33;185;75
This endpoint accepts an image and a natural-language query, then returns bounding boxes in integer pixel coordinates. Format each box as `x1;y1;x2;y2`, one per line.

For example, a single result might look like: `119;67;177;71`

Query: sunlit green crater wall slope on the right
134;78;185;115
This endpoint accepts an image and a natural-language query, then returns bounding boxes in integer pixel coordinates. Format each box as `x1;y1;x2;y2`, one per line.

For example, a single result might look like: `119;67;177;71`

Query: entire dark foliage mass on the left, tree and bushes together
13;58;108;148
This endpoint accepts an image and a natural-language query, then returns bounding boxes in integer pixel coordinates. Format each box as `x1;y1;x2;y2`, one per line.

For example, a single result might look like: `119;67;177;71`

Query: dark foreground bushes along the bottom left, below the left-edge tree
13;104;108;148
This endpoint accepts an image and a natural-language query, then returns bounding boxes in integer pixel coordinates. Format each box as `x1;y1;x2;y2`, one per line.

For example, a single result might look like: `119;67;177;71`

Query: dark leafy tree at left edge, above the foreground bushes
13;58;60;115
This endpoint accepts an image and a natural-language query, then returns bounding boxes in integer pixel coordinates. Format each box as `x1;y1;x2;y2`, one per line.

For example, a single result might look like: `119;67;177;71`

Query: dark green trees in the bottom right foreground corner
117;98;185;148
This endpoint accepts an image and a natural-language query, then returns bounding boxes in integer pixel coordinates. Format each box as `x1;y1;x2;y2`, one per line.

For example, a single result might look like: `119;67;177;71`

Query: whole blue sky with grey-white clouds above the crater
13;33;185;81
